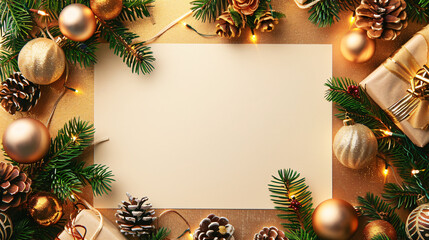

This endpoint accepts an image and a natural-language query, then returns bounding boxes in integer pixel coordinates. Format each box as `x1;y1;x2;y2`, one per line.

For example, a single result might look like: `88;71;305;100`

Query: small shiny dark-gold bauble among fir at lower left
28;193;63;226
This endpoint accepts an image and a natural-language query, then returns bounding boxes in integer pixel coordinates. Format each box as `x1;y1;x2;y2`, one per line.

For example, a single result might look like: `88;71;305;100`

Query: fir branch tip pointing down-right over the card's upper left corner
99;19;155;74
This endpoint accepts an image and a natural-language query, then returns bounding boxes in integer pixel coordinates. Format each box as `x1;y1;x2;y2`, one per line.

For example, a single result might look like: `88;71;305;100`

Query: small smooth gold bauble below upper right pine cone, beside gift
340;28;375;63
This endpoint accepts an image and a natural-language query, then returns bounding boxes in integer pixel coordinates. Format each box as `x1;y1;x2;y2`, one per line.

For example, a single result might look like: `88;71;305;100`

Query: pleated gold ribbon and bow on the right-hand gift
384;27;429;129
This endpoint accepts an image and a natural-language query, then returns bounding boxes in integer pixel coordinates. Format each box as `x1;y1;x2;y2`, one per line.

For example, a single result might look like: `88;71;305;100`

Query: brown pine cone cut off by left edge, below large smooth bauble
0;162;31;211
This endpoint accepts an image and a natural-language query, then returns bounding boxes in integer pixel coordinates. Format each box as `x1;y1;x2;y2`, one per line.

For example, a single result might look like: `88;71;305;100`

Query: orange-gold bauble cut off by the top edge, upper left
90;0;122;20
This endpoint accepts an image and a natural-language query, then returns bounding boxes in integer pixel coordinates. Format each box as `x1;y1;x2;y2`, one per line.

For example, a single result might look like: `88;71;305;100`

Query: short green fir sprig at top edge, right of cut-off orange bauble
117;0;155;21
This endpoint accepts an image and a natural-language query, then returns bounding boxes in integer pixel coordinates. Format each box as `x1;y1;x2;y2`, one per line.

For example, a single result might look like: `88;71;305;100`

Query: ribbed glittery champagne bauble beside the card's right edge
333;119;378;169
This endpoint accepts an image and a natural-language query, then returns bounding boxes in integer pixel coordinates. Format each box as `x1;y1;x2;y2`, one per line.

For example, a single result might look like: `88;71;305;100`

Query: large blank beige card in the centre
94;44;332;209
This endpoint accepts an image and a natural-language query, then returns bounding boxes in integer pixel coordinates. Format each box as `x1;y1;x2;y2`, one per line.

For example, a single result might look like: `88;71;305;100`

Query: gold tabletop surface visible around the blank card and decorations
0;0;423;240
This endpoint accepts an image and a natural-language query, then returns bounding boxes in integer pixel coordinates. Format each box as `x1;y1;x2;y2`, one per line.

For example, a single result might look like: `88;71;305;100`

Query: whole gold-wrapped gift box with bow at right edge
360;25;429;147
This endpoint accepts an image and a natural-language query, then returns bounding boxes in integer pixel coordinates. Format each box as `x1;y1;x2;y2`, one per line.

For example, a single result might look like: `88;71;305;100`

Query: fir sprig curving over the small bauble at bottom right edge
358;193;406;239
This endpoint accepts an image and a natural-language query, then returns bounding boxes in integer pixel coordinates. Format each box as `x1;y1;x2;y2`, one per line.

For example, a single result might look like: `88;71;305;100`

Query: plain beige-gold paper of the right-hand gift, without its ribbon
360;25;429;147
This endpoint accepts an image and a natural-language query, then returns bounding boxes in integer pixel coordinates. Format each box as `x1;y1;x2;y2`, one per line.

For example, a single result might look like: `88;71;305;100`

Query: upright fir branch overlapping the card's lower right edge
268;169;314;236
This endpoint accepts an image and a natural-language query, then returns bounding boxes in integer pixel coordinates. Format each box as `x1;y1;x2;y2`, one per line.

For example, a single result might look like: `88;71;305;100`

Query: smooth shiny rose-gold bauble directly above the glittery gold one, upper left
58;3;97;42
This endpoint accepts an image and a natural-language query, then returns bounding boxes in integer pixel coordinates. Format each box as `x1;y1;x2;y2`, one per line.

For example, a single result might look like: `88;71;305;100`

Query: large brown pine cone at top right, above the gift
356;0;408;40
